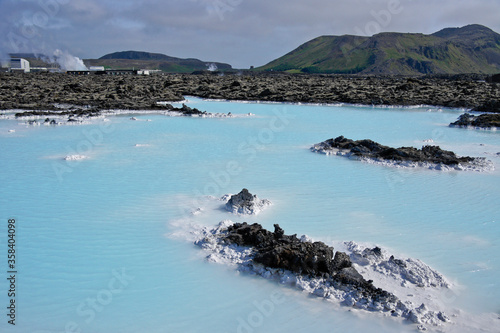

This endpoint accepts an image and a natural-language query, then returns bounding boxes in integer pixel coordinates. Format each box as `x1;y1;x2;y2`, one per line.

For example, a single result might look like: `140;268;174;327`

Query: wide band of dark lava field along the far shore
0;72;500;112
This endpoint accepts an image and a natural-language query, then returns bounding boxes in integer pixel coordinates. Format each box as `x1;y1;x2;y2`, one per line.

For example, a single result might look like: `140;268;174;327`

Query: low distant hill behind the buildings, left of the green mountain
84;51;232;73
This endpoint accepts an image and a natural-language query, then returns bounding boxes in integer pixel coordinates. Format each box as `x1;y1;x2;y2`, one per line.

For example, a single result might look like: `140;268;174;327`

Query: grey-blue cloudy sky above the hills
0;0;500;68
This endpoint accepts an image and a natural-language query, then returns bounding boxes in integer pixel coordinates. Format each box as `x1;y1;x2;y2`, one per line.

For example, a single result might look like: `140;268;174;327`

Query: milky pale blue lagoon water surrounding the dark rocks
0;98;500;333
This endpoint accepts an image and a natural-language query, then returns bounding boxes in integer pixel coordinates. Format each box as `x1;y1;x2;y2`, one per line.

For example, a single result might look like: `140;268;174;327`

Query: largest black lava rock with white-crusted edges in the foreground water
195;221;449;326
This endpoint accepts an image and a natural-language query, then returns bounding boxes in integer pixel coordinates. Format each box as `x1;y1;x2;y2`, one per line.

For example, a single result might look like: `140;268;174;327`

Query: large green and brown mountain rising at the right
257;24;500;75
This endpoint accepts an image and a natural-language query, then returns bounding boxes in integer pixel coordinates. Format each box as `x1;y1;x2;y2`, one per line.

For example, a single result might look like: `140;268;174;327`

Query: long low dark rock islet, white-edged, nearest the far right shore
311;136;491;171
